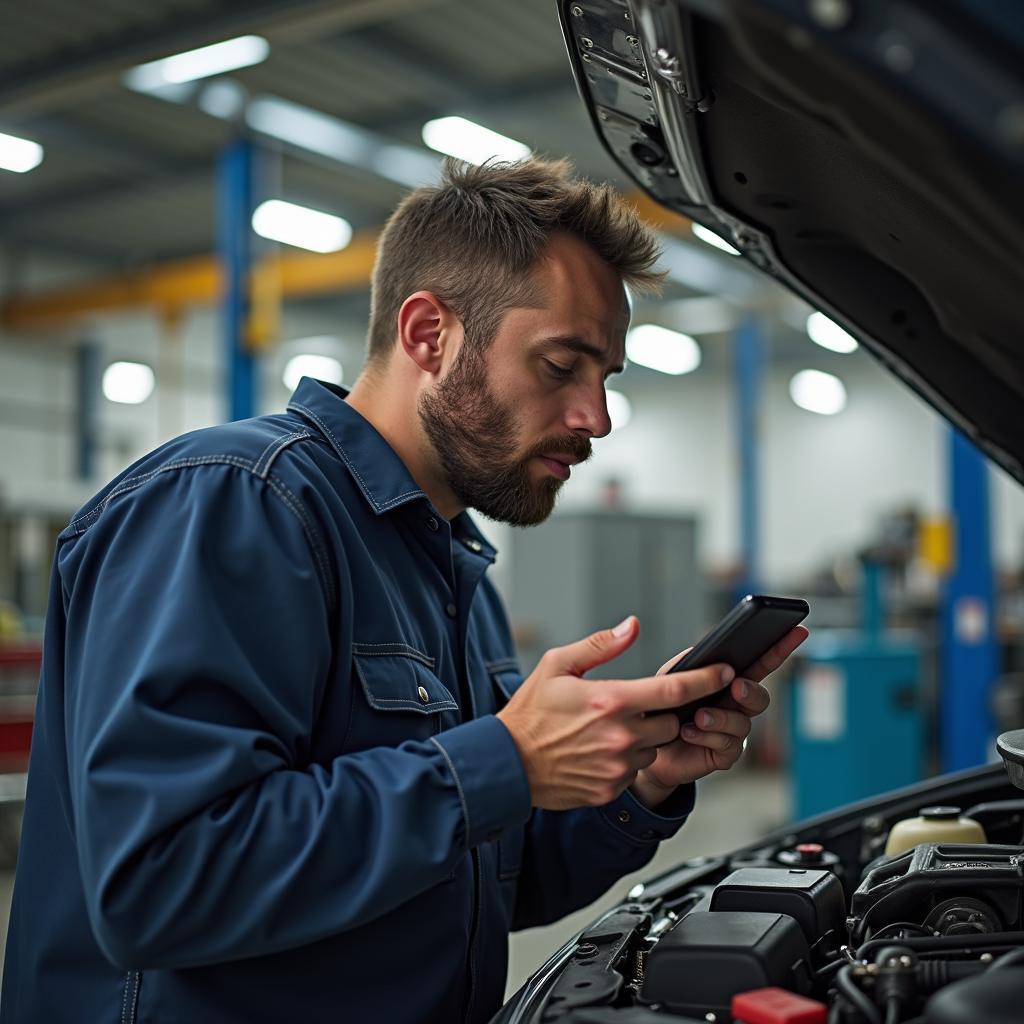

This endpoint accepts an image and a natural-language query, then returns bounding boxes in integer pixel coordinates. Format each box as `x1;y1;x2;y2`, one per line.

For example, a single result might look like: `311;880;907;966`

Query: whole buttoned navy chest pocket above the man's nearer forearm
345;643;459;751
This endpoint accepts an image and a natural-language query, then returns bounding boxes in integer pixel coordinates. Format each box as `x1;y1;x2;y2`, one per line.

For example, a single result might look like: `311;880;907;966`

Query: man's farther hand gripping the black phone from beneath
632;626;809;807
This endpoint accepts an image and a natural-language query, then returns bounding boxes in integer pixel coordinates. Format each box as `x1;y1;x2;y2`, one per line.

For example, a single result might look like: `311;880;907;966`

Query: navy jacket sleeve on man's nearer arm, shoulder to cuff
58;465;529;969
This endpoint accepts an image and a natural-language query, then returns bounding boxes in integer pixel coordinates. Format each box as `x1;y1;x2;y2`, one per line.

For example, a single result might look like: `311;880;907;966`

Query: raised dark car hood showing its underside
559;0;1024;482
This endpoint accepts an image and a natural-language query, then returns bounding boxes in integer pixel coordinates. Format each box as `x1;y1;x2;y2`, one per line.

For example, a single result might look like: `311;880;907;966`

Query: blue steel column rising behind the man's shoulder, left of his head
218;138;258;420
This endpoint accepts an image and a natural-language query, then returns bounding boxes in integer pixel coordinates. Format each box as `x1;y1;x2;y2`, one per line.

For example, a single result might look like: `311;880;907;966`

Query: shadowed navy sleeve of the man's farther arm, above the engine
512;784;695;931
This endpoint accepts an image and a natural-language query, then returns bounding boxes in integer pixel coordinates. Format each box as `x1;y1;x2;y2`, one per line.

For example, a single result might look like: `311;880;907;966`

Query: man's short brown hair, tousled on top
368;159;664;366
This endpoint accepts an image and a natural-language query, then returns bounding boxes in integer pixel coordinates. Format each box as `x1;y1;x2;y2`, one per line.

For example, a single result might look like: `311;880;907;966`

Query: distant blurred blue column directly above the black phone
733;319;764;598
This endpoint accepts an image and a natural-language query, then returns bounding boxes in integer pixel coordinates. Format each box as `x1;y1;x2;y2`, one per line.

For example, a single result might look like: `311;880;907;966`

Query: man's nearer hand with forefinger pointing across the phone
498;615;733;810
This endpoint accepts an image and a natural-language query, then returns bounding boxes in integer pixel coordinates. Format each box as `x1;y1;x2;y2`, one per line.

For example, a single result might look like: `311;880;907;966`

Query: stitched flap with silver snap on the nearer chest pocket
352;644;459;715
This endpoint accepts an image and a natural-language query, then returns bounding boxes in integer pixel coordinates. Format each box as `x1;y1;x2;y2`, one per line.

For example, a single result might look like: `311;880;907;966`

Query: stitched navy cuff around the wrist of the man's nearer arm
431;715;531;849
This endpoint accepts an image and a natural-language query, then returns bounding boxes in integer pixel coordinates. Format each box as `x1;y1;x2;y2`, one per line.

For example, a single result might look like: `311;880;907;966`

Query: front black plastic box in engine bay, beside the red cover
640;910;811;1020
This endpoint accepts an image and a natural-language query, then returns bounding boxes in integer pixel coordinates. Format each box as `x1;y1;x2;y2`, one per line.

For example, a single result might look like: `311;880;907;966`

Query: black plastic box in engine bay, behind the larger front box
711;867;846;952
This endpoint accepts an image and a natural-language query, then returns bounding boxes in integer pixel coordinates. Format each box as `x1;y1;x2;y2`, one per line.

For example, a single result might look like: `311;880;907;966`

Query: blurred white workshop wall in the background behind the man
0;301;1024;583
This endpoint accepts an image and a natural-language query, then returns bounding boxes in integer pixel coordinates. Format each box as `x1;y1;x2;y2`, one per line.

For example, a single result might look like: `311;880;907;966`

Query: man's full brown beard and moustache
418;345;591;526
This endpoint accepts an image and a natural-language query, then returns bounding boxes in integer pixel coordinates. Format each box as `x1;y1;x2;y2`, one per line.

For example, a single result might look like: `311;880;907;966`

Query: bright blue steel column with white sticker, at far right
941;430;998;771
